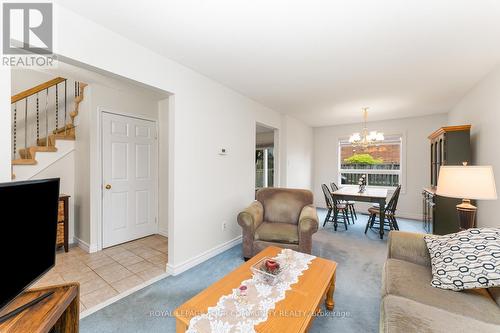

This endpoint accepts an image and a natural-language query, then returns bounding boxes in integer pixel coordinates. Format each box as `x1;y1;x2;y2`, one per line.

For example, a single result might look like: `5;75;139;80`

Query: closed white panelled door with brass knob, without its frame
101;112;158;248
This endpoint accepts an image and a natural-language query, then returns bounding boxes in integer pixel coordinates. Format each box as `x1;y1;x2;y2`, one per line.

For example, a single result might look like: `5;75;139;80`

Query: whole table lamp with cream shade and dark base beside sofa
436;163;497;230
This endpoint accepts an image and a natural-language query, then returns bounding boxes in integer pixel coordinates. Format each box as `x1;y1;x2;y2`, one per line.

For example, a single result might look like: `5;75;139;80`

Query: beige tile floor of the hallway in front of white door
34;235;168;312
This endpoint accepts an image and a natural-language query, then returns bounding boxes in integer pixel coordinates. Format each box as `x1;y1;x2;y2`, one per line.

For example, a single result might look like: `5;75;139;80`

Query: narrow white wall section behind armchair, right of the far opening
282;115;314;190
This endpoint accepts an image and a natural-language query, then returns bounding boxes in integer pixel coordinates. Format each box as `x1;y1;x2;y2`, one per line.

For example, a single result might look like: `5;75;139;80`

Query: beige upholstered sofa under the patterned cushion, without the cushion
380;231;500;333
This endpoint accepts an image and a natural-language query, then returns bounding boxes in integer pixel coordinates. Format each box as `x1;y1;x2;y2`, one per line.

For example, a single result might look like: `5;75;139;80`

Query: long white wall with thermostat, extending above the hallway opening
44;5;292;271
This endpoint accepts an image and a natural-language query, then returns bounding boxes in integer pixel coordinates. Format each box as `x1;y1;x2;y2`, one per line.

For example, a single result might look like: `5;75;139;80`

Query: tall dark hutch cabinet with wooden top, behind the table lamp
422;125;472;235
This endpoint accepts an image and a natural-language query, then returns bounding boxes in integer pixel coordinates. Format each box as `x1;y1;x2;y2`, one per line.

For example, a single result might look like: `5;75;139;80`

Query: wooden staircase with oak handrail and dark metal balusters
11;77;87;179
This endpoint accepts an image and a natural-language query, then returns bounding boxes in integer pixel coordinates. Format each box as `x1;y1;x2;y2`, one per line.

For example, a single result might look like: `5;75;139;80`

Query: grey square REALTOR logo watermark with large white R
2;2;56;67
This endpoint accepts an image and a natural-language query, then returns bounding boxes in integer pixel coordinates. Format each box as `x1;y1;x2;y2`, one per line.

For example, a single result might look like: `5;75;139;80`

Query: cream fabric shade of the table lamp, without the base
436;165;497;200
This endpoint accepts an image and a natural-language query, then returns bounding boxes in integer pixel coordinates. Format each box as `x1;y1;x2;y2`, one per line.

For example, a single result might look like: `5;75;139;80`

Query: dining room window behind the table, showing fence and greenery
339;135;403;187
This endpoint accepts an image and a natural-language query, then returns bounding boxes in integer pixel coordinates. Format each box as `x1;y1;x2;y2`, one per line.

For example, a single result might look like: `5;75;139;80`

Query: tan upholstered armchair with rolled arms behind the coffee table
238;188;318;259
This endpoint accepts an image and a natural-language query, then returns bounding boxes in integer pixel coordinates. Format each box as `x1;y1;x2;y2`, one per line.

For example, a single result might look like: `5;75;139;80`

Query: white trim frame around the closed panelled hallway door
96;106;160;252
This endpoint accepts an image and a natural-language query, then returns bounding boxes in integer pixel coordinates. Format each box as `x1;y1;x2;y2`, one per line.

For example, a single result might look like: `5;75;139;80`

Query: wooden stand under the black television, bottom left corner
0;283;80;333
